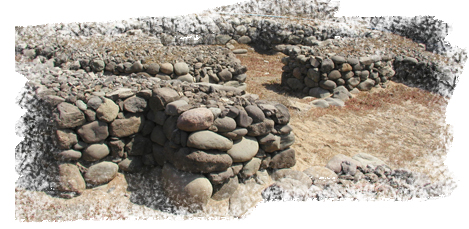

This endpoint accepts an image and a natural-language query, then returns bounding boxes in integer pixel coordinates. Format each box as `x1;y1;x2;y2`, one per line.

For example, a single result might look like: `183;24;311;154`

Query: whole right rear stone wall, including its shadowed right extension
281;45;460;98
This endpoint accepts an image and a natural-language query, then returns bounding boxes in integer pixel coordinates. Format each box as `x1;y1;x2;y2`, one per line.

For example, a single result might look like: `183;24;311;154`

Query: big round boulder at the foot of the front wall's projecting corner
161;163;213;211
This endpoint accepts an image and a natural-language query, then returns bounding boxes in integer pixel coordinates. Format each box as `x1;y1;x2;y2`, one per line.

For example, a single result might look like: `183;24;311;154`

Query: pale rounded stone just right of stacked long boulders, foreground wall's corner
227;136;259;162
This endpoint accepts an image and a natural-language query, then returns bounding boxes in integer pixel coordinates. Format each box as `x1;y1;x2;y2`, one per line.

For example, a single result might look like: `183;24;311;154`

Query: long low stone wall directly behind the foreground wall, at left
16;44;247;89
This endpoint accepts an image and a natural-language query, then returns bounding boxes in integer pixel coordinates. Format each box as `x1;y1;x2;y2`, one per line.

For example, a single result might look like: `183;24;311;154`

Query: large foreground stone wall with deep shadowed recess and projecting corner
29;61;296;210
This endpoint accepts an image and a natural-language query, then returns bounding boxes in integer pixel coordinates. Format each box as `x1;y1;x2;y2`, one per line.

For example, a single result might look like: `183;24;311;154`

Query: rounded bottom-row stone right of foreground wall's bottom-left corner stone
85;161;119;185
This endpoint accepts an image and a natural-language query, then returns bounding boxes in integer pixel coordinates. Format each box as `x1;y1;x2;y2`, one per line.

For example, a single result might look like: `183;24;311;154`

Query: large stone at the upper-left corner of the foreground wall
54;102;86;128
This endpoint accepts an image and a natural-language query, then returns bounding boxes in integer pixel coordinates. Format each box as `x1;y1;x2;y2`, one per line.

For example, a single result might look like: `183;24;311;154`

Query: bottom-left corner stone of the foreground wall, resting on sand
58;163;86;193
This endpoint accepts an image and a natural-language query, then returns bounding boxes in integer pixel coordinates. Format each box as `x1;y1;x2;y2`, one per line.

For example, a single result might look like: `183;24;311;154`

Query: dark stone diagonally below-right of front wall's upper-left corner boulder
77;121;109;143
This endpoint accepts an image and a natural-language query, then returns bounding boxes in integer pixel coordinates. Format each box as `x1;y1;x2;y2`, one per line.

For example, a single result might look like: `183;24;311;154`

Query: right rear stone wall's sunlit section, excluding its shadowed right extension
281;46;395;98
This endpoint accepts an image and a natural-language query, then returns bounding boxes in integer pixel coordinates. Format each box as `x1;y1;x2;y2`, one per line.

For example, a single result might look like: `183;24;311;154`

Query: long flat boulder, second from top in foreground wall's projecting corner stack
187;130;233;151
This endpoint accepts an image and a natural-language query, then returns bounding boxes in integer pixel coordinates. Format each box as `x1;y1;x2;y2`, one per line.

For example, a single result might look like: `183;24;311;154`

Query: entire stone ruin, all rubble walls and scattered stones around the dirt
15;0;456;218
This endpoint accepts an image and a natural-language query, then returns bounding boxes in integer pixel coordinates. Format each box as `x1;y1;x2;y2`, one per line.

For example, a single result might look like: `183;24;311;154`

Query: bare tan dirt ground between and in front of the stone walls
15;43;452;221
